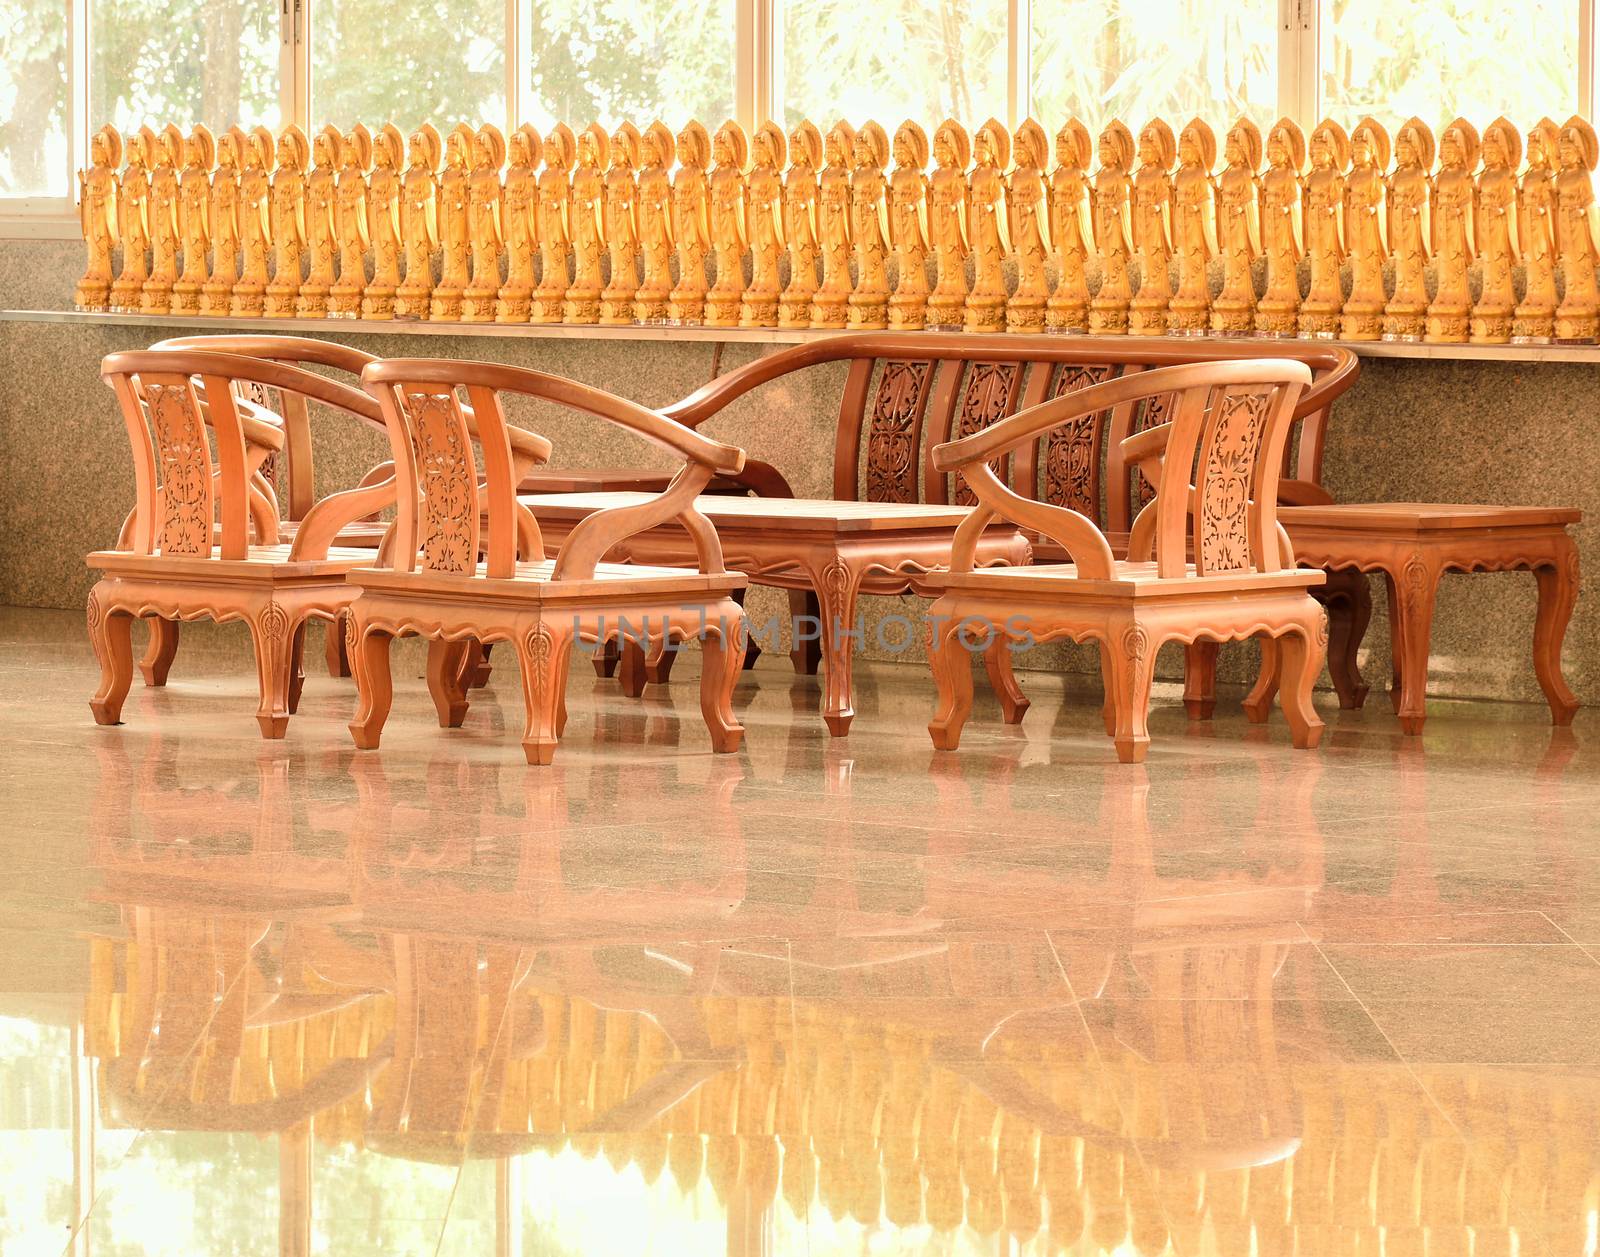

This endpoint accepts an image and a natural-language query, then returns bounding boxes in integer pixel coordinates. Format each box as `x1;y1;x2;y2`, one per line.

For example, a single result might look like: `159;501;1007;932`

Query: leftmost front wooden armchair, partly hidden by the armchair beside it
88;350;394;737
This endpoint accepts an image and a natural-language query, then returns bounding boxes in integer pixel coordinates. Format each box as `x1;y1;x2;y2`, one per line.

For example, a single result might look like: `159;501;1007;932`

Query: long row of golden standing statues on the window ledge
77;108;1600;344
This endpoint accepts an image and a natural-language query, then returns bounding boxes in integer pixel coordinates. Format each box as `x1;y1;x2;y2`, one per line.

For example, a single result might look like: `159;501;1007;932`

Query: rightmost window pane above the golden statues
1322;0;1589;131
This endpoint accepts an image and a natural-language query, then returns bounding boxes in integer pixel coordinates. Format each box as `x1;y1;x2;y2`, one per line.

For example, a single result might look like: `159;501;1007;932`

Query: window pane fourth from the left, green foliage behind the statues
523;0;736;130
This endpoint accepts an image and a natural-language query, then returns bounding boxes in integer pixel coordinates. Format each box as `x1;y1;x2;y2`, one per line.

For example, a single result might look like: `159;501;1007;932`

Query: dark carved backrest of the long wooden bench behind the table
662;333;1360;521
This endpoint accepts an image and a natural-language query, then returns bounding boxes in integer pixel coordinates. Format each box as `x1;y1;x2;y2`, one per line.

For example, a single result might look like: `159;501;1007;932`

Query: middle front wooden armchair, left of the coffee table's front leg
347;358;746;764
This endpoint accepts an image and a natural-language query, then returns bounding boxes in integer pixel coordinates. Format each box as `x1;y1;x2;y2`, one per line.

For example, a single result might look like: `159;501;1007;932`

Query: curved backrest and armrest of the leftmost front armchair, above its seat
101;349;382;558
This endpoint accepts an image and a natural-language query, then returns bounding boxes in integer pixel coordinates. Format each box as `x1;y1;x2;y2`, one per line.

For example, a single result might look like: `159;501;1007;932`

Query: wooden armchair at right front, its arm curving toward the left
926;358;1328;761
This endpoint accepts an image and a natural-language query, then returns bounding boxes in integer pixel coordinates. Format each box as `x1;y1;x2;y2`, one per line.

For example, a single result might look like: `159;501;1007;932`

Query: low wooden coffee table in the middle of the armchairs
518;493;1029;737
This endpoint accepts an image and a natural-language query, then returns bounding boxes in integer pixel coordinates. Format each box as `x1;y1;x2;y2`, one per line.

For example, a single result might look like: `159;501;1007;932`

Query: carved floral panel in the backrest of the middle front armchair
400;389;478;573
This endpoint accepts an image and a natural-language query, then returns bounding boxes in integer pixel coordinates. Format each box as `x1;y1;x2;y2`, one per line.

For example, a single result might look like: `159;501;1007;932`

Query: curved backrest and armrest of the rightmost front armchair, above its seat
933;358;1310;577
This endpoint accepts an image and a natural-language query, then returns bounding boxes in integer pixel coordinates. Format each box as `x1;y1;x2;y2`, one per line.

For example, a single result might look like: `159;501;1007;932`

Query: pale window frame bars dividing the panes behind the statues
0;0;1600;240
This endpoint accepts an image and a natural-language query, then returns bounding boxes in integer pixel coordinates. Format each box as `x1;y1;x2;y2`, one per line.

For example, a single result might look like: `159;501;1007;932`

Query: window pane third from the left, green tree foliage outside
310;0;506;134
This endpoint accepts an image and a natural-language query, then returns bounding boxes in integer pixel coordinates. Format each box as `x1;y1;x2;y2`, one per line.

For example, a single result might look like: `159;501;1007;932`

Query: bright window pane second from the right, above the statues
1034;0;1278;134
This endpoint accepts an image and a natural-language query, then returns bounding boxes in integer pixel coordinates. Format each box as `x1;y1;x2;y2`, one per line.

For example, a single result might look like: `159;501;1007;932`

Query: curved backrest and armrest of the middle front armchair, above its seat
362;358;744;579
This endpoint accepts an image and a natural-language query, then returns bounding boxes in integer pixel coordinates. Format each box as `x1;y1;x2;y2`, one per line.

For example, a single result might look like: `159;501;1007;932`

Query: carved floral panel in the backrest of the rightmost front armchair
1194;387;1275;573
